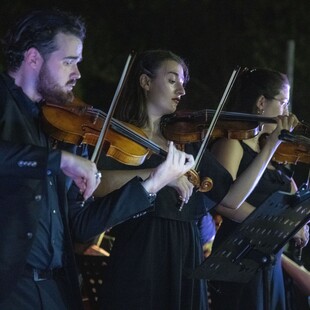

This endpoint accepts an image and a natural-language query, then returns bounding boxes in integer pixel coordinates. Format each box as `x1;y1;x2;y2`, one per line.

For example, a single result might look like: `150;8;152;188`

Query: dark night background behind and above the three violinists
0;0;310;266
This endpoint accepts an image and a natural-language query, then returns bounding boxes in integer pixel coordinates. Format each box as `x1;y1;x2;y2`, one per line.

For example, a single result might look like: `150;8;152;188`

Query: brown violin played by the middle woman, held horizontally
161;110;277;144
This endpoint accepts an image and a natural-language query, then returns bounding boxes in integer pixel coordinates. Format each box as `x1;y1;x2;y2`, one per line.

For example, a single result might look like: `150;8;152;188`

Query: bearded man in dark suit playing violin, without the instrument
0;10;193;310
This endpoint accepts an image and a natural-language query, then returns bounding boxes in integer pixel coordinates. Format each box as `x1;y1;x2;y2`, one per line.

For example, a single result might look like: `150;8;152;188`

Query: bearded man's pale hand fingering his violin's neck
142;142;194;193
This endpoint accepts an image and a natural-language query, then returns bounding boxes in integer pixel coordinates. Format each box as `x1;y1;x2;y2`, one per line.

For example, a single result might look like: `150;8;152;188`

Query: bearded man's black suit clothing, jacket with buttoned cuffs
0;74;155;310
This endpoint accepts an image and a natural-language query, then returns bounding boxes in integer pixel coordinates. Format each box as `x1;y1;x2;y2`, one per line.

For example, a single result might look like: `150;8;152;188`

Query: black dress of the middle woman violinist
98;146;232;310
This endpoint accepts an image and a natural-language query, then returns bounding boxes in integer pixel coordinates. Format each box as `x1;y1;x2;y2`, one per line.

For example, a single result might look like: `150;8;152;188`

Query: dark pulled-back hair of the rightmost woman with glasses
228;68;289;113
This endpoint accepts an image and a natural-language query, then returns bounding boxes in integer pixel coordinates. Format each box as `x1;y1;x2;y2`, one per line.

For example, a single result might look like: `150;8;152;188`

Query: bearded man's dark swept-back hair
2;9;86;71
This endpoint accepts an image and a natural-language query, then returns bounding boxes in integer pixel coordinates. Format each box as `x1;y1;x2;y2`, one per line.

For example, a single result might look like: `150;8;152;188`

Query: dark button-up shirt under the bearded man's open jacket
4;75;64;269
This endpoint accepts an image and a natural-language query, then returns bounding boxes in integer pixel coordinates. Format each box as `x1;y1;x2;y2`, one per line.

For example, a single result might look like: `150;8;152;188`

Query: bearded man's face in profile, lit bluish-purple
37;33;83;105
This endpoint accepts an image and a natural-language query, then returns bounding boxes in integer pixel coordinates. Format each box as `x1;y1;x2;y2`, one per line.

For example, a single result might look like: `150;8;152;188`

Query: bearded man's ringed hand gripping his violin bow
60;151;100;200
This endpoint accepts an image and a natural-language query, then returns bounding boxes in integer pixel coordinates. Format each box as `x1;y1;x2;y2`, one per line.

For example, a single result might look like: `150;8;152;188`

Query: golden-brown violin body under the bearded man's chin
42;99;167;166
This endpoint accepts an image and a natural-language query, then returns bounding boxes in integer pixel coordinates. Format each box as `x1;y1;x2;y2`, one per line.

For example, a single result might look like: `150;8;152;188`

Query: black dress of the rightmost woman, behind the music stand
210;142;291;310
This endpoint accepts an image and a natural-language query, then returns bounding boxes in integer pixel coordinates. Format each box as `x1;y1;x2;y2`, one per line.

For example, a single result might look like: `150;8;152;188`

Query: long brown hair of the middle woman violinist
116;50;189;127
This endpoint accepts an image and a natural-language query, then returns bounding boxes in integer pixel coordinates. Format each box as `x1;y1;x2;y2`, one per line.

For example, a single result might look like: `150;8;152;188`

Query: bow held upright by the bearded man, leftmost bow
91;52;136;163
